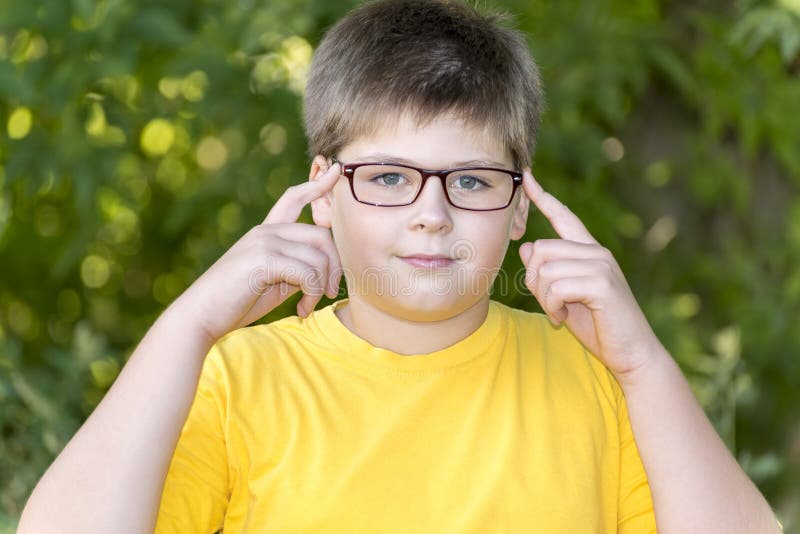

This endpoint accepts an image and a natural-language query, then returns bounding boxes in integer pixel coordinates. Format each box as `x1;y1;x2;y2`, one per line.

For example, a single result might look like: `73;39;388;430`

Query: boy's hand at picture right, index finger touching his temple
519;169;661;379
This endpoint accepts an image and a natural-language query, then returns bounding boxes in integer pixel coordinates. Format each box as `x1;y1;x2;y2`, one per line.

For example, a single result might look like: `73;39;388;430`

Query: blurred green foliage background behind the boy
0;0;800;532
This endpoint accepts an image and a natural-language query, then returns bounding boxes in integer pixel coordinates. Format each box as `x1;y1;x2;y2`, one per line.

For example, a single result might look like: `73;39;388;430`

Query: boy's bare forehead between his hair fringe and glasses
339;108;512;168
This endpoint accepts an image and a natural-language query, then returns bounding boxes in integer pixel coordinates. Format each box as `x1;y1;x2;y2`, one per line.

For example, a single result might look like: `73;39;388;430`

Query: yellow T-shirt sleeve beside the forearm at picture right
615;388;656;534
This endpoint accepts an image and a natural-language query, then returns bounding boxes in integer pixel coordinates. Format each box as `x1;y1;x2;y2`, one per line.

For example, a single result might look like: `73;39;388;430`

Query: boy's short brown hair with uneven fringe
303;0;543;169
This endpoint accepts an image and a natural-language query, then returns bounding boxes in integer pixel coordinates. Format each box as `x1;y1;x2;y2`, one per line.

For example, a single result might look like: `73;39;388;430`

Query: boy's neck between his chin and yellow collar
335;295;489;355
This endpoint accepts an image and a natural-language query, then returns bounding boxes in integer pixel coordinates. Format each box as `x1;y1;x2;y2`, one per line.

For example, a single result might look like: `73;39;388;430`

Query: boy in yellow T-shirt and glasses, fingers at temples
20;0;778;533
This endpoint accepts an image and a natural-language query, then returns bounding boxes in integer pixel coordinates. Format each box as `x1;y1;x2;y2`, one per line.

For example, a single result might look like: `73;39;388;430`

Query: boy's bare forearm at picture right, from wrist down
620;347;780;534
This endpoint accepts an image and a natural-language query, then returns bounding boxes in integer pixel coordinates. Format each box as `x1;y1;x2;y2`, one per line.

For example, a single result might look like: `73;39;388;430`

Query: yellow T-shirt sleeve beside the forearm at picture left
155;345;229;534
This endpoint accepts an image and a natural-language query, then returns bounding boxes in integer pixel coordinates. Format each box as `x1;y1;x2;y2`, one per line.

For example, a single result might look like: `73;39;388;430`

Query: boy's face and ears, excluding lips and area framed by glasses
310;110;528;321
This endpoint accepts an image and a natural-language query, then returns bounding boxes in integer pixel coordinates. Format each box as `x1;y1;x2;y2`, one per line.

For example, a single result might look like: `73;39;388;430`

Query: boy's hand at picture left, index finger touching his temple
175;164;342;343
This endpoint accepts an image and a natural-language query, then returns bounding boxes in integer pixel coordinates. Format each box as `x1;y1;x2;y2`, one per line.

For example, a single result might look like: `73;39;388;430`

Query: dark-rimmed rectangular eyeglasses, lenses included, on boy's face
331;157;522;211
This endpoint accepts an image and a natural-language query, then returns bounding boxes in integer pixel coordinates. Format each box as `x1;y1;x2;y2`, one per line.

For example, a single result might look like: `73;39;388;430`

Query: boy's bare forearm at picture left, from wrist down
18;301;217;534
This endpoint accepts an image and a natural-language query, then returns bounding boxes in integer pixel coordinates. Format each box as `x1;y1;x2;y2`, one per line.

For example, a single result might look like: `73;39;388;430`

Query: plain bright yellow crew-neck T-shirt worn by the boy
156;299;656;534
